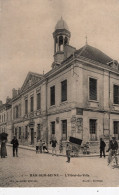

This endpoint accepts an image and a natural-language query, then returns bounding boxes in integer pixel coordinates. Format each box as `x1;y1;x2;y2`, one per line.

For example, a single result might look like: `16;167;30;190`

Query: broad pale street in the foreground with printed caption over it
0;147;119;187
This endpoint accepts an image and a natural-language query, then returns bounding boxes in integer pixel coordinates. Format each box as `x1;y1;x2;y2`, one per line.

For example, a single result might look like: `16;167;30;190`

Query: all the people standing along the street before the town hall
1;136;118;165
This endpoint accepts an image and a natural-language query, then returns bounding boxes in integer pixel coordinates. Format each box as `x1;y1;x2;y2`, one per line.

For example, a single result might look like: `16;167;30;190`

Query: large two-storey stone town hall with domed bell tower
0;18;119;145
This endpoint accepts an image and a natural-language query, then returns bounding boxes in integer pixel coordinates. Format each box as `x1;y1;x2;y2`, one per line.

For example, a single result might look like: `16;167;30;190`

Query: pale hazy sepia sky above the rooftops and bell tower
0;0;119;103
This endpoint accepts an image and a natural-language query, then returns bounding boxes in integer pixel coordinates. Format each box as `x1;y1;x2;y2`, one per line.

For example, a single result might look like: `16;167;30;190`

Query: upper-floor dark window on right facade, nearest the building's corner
89;78;97;100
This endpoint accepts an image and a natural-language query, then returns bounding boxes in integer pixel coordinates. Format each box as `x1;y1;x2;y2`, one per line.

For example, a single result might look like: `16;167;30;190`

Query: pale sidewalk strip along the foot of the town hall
7;143;102;157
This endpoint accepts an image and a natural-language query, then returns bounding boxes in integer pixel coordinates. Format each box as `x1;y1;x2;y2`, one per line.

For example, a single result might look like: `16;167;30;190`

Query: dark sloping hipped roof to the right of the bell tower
75;45;113;64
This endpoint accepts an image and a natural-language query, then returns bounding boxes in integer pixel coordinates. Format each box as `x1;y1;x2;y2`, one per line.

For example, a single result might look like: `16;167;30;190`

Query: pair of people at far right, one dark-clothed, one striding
100;137;118;165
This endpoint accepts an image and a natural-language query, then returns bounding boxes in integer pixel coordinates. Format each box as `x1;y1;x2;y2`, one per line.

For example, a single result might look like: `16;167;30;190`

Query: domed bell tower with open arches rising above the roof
52;17;71;68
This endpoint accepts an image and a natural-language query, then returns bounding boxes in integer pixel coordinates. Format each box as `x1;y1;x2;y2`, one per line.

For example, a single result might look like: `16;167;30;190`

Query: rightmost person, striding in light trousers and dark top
107;137;118;165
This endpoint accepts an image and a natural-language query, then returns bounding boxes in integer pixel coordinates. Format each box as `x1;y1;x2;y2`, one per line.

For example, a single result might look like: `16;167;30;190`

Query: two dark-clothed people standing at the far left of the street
1;136;19;158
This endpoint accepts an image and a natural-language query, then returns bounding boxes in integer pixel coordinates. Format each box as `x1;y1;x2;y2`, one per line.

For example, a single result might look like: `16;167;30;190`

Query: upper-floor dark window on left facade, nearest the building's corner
61;80;67;102
